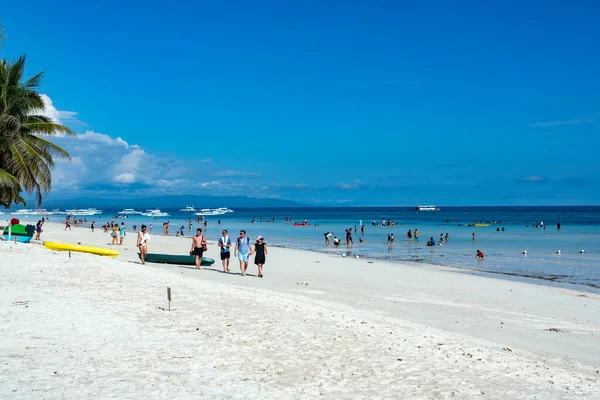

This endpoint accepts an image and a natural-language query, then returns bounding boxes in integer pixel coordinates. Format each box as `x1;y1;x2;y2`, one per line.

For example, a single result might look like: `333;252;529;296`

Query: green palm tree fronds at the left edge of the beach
0;56;74;207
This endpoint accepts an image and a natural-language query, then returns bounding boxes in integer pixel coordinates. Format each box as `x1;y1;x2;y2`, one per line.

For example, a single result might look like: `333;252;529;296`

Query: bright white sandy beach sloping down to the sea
0;224;600;399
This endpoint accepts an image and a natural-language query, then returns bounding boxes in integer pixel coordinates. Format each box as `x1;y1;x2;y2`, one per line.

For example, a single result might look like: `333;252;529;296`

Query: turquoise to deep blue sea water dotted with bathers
10;206;600;293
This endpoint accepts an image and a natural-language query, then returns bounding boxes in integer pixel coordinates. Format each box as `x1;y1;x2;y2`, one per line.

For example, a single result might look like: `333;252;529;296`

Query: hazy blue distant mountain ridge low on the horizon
42;195;303;209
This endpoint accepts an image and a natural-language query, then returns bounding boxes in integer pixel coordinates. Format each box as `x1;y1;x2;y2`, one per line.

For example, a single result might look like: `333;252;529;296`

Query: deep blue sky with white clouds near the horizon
0;0;600;206
